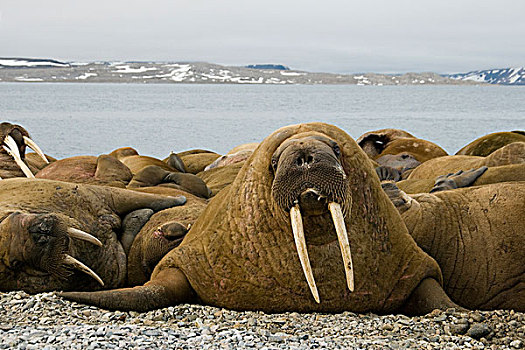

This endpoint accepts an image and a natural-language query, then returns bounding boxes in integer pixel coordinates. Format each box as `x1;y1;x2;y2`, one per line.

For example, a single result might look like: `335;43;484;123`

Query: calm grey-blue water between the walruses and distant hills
0;83;525;158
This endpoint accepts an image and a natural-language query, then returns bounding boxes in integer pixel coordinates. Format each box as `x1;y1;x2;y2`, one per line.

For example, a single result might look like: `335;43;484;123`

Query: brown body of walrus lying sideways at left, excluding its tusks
0;178;185;293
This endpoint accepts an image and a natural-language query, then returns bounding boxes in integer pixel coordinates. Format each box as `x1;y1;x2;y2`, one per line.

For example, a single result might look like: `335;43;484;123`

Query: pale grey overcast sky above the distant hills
0;0;525;73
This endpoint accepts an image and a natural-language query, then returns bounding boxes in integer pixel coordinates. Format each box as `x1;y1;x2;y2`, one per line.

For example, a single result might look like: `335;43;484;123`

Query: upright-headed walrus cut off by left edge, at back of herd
0;122;49;179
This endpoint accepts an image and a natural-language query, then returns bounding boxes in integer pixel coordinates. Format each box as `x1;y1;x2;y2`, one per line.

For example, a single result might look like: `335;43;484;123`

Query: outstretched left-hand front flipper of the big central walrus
58;268;196;312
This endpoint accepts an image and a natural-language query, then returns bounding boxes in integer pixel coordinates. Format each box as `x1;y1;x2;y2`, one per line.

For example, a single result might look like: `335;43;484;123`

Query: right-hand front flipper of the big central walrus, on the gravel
399;278;465;316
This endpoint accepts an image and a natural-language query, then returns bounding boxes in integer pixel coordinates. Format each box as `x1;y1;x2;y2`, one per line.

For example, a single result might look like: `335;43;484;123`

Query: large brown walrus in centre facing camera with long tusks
62;123;455;313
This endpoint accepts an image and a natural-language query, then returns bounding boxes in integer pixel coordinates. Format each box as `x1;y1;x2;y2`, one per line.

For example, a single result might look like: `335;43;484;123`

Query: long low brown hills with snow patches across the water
0;57;482;86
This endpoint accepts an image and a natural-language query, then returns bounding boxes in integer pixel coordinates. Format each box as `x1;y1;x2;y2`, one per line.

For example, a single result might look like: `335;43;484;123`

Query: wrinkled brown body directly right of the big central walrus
392;181;525;312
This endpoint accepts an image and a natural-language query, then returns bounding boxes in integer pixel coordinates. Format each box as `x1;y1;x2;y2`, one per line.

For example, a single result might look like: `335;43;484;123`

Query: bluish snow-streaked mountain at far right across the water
447;67;525;85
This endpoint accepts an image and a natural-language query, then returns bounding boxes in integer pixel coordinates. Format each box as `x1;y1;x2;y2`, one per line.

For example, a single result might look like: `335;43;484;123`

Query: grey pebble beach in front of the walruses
0;292;525;350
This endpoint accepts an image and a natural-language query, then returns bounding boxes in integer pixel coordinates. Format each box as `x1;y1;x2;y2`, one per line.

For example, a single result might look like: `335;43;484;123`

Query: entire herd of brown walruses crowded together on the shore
0;122;525;315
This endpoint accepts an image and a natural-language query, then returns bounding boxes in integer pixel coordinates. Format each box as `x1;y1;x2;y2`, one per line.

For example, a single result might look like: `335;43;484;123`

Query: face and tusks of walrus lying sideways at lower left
0;212;103;285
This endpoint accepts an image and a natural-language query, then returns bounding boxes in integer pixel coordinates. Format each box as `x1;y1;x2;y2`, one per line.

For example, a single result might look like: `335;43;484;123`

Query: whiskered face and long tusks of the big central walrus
271;135;354;303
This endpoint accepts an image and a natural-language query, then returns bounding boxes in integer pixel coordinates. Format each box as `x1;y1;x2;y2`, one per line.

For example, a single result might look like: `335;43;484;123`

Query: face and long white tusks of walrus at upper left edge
0;122;49;177
